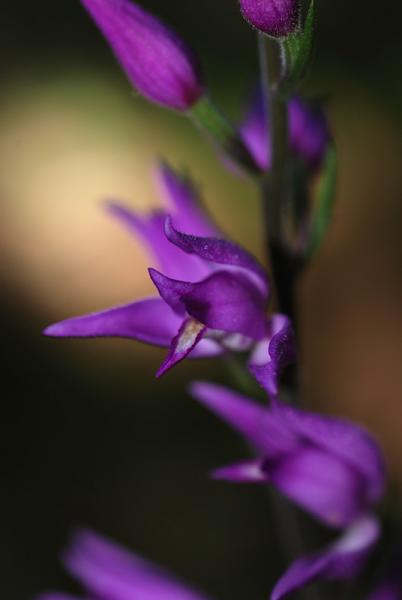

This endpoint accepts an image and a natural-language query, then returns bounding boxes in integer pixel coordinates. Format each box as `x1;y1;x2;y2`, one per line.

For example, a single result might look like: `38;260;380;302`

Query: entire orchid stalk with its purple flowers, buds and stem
37;0;390;600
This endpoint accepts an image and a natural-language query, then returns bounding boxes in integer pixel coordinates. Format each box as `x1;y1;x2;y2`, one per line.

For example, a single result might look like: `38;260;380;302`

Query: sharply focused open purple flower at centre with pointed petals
45;165;293;382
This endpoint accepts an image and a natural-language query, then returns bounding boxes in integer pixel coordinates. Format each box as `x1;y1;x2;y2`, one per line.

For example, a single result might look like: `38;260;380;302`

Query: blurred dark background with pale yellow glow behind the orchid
0;0;402;600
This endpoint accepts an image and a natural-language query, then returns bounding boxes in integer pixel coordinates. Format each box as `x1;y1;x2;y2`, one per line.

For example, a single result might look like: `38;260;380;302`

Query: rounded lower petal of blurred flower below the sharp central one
263;446;368;527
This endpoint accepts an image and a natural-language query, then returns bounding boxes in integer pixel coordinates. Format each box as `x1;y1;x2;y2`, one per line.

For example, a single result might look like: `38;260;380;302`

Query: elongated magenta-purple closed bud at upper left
82;0;204;111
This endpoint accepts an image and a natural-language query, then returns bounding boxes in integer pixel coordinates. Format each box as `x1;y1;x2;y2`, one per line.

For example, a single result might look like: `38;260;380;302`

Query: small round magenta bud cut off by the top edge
240;0;300;38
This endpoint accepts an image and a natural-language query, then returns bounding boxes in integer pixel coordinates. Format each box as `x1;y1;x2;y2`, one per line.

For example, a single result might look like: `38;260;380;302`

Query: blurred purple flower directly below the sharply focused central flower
191;382;385;528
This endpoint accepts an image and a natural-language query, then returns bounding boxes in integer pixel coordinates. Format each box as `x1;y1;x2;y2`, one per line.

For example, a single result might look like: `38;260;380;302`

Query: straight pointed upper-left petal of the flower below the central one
190;382;297;458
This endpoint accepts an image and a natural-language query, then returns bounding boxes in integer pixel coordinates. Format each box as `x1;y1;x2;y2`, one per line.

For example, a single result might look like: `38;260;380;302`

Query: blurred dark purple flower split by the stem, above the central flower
240;90;330;171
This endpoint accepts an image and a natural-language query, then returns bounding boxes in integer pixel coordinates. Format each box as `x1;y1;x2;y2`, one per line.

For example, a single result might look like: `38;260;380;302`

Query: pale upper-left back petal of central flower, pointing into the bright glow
107;202;210;281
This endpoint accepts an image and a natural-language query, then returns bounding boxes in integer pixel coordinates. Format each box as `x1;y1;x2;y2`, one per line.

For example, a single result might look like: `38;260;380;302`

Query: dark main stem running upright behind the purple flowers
258;34;319;600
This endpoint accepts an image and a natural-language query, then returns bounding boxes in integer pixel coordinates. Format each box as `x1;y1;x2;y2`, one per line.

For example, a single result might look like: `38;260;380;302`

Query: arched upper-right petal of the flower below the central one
280;405;385;503
